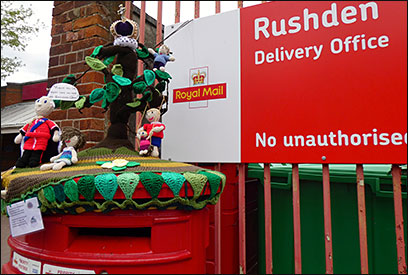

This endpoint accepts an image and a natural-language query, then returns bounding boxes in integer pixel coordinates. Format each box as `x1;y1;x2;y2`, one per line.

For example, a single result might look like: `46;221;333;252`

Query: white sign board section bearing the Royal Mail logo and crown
162;10;241;162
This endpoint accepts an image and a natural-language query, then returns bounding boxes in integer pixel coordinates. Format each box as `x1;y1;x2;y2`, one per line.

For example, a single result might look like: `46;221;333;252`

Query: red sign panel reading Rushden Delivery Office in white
240;1;407;163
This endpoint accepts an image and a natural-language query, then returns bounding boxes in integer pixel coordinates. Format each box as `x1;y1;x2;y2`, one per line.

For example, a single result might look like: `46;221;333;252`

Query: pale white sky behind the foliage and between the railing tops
1;1;261;86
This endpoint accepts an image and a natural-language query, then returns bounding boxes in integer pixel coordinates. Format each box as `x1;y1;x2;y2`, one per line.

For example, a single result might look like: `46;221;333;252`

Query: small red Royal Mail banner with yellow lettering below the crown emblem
173;83;227;103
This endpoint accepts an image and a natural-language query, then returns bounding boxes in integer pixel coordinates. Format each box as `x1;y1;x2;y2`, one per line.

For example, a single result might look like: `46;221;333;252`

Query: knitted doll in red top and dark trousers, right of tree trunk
143;108;166;157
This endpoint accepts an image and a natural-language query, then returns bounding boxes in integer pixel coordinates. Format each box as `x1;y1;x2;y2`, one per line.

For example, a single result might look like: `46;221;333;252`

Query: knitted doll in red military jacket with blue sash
14;96;60;168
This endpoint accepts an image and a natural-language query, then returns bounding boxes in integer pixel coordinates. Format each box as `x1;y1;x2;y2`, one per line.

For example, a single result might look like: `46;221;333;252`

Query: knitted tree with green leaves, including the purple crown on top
56;4;171;149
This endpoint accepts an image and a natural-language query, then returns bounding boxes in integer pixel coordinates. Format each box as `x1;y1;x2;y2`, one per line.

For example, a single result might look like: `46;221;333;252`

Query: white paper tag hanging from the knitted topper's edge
7;197;44;237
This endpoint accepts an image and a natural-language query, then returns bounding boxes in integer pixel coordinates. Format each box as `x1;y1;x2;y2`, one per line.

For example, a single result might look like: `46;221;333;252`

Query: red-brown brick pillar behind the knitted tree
48;1;124;149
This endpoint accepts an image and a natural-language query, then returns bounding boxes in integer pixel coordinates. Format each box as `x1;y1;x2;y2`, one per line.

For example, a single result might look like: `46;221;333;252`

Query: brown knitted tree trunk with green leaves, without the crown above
66;44;171;149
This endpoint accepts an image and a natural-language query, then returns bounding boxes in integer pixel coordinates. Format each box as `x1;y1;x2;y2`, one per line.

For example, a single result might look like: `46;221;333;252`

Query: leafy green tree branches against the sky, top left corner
1;1;43;79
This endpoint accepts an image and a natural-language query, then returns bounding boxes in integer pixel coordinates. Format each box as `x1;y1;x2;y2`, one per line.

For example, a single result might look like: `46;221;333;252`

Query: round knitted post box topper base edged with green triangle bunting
2;147;226;215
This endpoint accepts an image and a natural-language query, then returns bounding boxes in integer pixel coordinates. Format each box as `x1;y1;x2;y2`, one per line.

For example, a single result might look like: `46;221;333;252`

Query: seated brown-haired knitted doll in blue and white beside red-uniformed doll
40;127;86;171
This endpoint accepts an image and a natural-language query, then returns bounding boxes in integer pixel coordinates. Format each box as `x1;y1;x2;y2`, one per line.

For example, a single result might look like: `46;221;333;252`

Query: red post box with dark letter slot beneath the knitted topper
2;208;209;274
